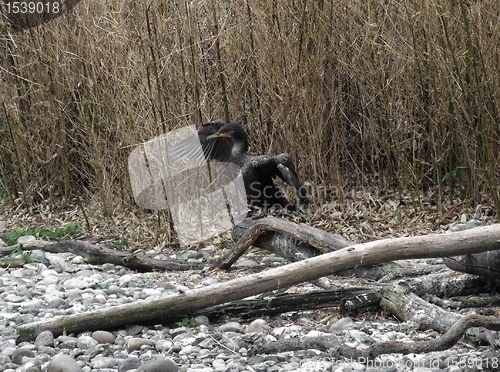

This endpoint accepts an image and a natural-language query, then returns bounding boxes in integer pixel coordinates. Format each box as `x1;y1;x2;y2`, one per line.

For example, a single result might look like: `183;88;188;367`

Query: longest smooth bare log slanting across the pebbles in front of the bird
18;219;500;341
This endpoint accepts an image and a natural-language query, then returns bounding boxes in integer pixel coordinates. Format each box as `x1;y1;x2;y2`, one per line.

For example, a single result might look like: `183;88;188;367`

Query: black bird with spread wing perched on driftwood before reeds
171;119;309;213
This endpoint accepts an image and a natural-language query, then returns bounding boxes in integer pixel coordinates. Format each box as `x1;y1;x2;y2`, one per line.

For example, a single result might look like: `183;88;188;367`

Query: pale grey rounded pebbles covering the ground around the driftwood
0;247;492;372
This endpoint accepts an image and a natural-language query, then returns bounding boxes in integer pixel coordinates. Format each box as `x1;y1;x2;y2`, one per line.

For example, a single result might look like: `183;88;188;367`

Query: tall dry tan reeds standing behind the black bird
0;0;500;243
